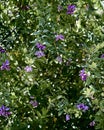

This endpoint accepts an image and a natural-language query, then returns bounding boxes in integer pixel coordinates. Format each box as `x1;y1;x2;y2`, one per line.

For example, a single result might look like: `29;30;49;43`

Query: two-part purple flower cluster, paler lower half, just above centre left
35;43;46;58
